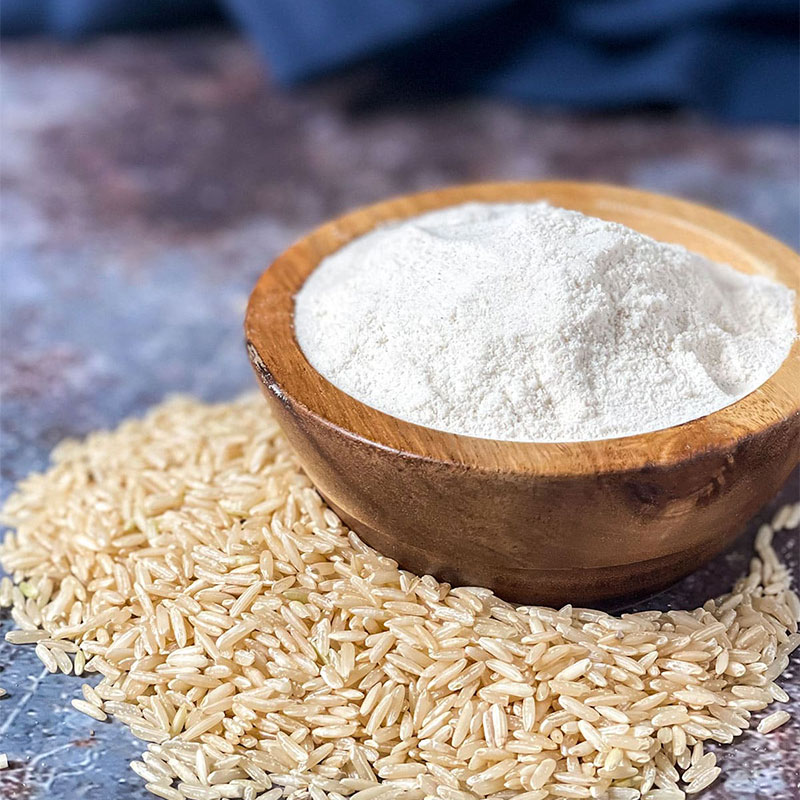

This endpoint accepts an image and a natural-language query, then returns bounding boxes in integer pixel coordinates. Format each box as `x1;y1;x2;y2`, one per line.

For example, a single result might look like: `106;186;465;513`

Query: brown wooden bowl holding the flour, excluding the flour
245;182;800;605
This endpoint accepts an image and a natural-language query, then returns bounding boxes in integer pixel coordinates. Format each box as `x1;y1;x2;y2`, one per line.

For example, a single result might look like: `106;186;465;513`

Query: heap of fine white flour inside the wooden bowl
295;203;796;442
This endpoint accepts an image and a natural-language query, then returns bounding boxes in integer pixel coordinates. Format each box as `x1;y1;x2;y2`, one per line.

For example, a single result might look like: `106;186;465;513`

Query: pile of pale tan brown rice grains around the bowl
0;397;800;800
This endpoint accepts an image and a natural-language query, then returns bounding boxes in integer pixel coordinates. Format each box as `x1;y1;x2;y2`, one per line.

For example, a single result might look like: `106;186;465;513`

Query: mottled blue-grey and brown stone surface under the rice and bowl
0;33;800;800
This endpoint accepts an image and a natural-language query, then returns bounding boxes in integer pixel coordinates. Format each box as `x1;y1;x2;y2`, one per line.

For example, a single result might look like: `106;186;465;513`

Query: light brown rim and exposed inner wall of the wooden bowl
244;181;800;478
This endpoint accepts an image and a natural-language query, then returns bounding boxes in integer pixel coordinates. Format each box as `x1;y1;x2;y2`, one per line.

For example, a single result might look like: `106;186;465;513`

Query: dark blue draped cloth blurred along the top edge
0;0;800;123
